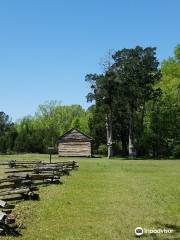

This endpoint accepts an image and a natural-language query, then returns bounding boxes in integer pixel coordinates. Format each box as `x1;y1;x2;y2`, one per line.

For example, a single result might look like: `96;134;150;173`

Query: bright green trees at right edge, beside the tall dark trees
144;45;180;158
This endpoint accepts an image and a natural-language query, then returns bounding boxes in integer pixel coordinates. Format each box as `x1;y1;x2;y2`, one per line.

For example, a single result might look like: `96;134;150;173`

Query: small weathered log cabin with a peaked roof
58;128;93;157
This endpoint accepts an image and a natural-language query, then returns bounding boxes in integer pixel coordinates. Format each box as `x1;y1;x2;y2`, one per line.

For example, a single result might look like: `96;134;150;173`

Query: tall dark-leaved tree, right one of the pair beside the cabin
112;46;161;157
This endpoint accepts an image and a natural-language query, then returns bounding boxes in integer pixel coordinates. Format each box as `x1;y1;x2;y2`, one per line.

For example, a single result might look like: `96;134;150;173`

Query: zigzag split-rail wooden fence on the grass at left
0;160;79;236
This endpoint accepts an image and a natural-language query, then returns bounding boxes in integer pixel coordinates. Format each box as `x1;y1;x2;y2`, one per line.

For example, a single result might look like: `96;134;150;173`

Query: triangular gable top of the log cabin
58;128;93;142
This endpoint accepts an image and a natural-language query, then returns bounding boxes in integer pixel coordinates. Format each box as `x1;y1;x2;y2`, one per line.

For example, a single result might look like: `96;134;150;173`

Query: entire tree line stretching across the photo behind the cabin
0;45;180;158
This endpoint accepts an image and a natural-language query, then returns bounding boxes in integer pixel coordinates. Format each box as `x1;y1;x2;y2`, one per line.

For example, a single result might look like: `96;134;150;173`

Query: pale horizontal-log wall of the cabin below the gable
58;141;91;156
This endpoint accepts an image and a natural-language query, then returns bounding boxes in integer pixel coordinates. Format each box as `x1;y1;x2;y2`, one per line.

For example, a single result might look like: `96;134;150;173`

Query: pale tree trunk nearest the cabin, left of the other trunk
106;112;113;158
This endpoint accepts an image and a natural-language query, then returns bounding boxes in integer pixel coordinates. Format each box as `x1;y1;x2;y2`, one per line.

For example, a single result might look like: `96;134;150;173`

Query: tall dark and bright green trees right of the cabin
86;45;180;158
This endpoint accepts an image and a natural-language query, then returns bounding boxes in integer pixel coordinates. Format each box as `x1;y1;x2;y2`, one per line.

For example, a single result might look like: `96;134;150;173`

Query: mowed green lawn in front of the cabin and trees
0;154;180;240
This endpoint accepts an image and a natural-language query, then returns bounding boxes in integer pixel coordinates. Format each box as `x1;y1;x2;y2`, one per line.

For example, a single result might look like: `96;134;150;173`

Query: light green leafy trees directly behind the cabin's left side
14;101;89;153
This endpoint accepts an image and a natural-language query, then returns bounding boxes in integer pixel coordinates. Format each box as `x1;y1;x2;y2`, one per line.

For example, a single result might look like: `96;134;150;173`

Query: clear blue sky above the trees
0;0;180;120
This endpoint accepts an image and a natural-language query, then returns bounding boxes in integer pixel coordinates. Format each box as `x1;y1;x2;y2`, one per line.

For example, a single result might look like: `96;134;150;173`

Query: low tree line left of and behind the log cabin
0;101;89;153
